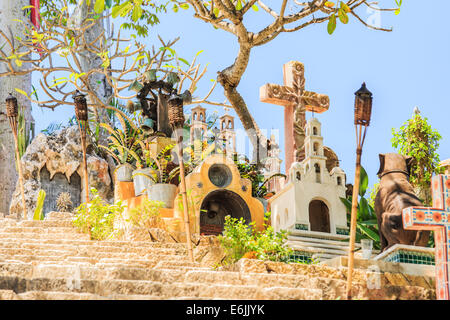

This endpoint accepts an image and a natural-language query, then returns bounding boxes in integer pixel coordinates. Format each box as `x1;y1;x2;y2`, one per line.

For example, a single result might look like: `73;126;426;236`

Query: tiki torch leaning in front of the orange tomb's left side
167;93;194;262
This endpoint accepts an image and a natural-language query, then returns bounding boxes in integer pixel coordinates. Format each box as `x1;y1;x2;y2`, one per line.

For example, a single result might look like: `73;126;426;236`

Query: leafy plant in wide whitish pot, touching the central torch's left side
147;145;184;208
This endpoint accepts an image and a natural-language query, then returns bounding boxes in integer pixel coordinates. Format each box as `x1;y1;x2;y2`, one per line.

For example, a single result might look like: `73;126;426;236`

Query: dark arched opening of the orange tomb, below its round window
200;189;252;235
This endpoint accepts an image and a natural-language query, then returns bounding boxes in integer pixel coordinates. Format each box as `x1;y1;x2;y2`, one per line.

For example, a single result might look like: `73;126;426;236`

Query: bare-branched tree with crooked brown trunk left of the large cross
163;0;402;154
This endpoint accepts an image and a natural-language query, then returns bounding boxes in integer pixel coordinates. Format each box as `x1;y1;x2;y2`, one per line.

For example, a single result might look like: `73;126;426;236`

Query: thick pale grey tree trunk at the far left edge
0;0;33;214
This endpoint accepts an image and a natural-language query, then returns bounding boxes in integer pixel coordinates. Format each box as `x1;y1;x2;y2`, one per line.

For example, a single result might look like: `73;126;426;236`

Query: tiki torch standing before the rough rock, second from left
72;90;89;203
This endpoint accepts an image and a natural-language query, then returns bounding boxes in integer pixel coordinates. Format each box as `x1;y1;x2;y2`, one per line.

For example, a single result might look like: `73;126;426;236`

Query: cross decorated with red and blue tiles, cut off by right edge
403;174;450;300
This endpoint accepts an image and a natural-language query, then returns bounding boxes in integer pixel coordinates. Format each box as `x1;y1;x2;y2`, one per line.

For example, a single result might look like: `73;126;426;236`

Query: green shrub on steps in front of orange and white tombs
218;215;292;263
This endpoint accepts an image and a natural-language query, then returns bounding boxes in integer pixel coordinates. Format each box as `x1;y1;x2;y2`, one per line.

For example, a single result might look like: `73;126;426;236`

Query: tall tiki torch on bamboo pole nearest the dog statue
347;83;372;300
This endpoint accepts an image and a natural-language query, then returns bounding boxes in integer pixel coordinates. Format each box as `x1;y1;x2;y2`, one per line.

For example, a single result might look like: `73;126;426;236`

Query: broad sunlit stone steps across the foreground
0;213;434;300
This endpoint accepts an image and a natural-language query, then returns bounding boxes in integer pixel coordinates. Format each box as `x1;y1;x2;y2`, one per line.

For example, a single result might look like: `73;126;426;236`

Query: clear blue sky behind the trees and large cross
33;0;450;190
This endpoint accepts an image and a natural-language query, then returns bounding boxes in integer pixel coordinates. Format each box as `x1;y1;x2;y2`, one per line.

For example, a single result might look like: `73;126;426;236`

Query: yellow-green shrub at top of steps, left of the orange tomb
73;188;125;240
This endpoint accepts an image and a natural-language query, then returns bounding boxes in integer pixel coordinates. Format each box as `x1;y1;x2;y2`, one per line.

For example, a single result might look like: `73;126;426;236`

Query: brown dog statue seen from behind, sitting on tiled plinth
375;153;430;251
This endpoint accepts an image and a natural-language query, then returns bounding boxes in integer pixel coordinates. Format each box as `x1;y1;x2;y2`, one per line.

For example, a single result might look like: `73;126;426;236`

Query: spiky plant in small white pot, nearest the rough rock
99;113;141;182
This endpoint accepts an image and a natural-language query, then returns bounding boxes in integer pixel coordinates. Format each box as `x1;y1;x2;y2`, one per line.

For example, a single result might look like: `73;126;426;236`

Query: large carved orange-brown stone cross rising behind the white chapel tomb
259;61;330;172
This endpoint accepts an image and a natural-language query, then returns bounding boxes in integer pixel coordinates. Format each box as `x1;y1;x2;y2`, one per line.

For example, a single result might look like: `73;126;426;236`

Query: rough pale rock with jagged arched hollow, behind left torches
9;126;113;219
